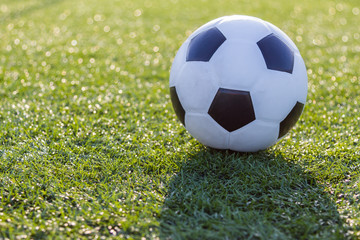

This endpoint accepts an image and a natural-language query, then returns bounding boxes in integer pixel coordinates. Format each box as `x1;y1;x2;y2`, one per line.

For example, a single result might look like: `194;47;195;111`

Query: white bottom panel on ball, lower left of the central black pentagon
185;113;229;149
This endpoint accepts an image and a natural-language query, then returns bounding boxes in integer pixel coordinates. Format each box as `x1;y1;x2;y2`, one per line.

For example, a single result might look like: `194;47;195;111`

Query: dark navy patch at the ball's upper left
186;27;226;62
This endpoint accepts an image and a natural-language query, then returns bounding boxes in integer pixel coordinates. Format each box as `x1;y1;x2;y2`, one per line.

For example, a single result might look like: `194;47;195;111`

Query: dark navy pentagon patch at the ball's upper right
257;33;294;73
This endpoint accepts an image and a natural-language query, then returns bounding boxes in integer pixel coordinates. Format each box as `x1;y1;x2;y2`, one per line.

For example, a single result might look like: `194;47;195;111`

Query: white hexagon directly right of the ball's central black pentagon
251;70;299;122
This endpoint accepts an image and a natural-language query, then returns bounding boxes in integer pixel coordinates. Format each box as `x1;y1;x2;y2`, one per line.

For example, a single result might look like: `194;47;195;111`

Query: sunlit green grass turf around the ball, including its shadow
0;0;360;239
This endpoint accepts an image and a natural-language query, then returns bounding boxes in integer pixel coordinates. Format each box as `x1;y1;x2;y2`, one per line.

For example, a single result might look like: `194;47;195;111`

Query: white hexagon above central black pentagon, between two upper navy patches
210;40;267;90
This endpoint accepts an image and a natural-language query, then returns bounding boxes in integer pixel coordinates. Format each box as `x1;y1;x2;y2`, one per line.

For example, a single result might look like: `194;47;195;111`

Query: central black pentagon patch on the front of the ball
208;88;255;132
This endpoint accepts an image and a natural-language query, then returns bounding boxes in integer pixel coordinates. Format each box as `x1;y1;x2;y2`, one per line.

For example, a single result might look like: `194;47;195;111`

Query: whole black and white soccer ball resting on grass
170;15;307;152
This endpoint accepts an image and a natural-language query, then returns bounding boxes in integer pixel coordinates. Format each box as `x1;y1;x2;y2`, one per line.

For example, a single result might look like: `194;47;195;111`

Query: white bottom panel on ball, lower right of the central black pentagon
229;120;279;152
